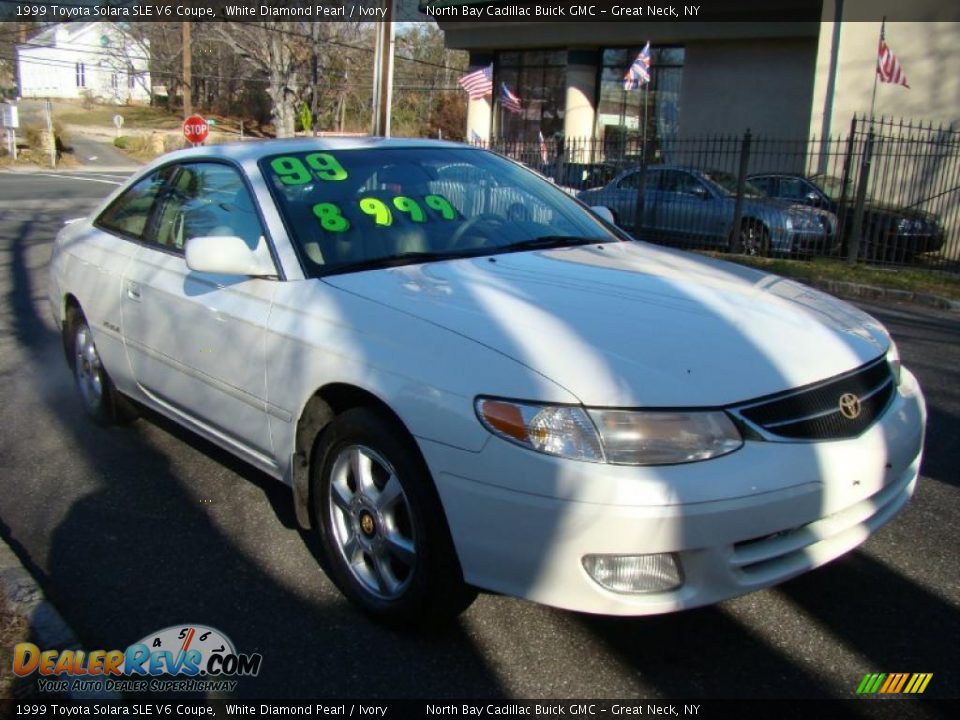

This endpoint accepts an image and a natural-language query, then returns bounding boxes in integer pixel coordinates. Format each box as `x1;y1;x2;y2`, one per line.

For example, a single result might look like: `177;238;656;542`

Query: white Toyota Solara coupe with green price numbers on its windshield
50;138;926;624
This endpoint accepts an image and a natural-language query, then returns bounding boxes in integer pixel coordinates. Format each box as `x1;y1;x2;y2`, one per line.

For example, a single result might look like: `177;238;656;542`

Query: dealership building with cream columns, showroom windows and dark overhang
435;0;960;148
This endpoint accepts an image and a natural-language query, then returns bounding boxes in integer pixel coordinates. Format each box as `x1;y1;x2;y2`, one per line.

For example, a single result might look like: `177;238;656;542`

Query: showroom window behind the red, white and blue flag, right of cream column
597;46;684;161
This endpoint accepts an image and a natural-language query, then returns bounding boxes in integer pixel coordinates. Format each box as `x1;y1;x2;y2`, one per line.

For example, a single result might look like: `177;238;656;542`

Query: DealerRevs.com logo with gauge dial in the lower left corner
13;625;263;692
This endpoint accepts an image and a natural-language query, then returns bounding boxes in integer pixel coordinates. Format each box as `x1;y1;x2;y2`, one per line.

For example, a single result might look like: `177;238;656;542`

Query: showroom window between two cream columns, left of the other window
493;50;567;142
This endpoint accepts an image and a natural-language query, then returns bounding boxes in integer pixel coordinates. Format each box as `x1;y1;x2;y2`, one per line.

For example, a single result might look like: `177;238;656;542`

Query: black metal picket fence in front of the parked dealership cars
480;117;960;272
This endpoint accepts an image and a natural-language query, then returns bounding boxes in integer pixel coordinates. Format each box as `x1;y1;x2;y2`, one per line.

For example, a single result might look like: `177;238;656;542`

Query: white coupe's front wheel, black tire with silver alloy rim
311;408;476;626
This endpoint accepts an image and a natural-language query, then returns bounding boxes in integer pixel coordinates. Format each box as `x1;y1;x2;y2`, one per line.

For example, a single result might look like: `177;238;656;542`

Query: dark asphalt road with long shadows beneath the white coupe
0;173;960;704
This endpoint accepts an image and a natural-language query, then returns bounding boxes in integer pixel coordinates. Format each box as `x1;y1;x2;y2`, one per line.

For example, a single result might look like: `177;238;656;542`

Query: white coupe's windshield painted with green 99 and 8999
260;147;620;276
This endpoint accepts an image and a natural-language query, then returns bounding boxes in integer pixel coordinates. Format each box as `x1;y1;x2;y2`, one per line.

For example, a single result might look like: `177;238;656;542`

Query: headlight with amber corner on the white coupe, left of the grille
475;398;743;465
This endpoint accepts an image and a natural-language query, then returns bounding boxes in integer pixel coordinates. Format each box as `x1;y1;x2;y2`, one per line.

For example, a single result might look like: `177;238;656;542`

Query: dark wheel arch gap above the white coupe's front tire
290;383;416;530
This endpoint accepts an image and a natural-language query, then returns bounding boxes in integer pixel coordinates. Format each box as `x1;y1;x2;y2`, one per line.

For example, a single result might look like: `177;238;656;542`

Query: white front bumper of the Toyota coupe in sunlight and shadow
421;370;926;615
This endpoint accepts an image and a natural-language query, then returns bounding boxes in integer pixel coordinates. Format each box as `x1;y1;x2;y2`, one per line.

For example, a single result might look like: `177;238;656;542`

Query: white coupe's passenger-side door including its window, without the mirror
122;162;276;466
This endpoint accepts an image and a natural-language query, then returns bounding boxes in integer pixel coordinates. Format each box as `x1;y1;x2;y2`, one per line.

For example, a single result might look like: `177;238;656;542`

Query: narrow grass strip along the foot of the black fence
706;253;960;300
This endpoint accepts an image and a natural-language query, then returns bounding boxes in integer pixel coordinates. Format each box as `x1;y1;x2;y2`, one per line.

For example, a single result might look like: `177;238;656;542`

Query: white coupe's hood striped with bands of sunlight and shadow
324;242;889;407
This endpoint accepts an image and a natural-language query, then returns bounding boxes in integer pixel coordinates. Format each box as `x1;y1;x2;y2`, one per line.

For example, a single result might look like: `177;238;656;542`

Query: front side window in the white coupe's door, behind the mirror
153;162;264;250
